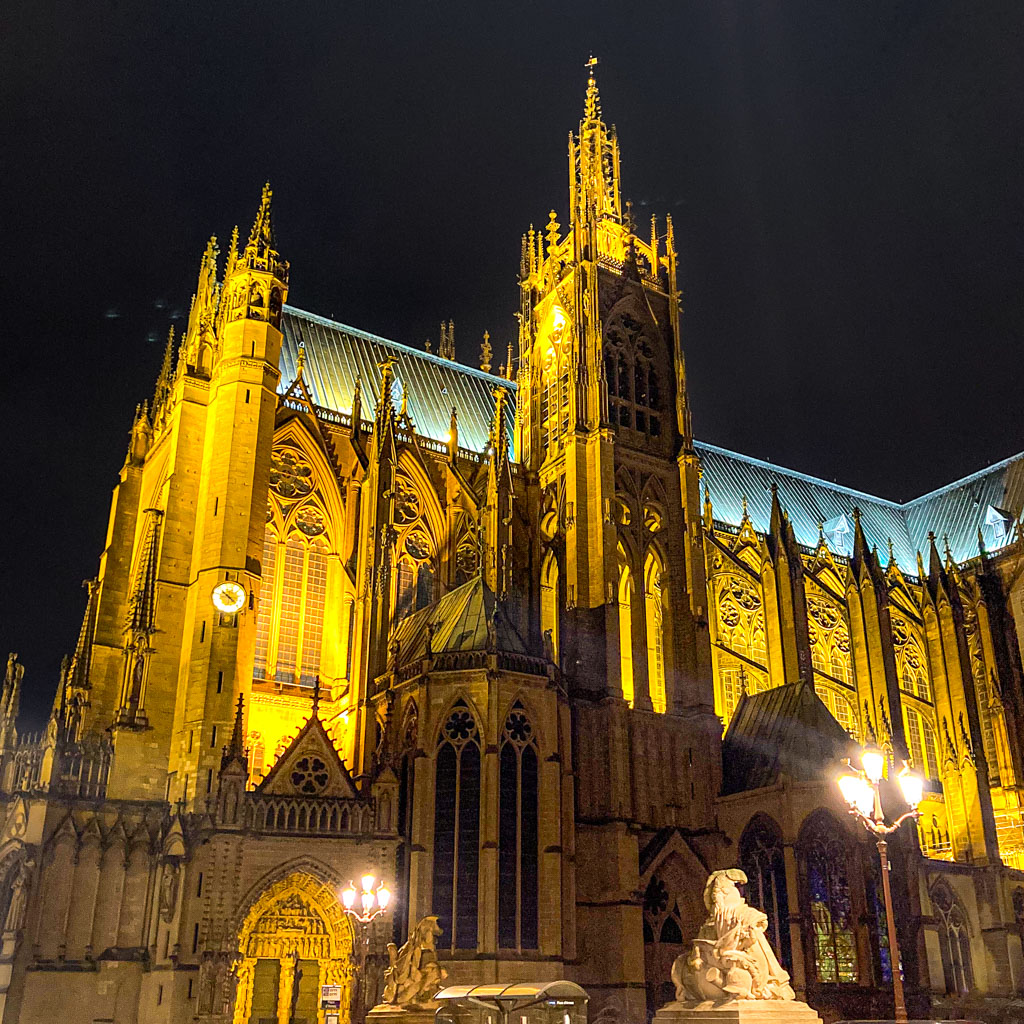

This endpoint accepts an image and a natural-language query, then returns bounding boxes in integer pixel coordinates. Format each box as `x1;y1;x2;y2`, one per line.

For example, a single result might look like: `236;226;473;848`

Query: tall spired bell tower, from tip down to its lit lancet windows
516;58;713;712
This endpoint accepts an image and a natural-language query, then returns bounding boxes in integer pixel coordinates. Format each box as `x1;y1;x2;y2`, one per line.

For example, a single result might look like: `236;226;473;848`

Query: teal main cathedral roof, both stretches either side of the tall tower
281;306;1024;573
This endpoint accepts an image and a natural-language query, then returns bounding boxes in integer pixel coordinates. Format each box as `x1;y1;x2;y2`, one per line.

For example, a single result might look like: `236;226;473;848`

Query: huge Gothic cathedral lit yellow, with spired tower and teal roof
0;69;1024;1024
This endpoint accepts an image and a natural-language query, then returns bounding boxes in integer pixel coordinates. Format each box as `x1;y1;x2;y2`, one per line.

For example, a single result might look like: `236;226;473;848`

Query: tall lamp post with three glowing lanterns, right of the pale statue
837;743;925;1021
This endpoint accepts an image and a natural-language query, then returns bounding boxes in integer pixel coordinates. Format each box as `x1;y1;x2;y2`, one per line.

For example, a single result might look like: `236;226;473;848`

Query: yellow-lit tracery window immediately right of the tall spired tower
715;574;768;723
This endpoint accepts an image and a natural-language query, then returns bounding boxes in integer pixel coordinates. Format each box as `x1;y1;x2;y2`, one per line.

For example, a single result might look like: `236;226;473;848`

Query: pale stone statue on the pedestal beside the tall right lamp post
672;867;796;1009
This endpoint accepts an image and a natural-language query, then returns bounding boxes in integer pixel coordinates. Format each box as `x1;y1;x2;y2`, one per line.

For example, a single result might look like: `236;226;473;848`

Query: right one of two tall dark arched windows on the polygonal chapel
498;700;538;949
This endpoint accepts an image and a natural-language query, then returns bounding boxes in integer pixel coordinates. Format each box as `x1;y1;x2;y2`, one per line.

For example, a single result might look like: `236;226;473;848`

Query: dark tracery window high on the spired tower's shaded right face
604;313;663;437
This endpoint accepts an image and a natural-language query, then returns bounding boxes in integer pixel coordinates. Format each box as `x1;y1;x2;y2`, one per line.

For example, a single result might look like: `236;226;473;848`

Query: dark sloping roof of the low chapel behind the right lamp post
722;682;855;797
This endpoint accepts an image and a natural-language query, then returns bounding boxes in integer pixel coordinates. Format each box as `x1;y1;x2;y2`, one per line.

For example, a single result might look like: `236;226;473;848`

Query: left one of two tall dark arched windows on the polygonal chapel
433;700;480;950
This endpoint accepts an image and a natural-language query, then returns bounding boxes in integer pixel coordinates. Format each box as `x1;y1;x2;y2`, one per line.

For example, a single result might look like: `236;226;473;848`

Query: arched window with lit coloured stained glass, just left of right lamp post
802;814;858;984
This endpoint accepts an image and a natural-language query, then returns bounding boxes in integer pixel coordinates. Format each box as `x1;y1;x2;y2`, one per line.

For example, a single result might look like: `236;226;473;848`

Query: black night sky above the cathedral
0;0;1024;725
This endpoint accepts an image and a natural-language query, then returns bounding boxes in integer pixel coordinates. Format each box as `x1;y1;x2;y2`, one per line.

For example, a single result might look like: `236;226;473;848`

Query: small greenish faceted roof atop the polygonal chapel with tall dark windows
385;575;528;665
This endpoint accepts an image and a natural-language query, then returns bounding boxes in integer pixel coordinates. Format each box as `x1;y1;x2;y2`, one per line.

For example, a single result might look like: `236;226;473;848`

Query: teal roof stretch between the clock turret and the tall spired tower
281;305;515;452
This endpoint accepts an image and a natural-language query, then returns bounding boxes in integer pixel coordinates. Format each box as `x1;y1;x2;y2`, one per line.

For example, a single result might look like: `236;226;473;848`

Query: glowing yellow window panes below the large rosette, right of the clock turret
253;487;329;686
